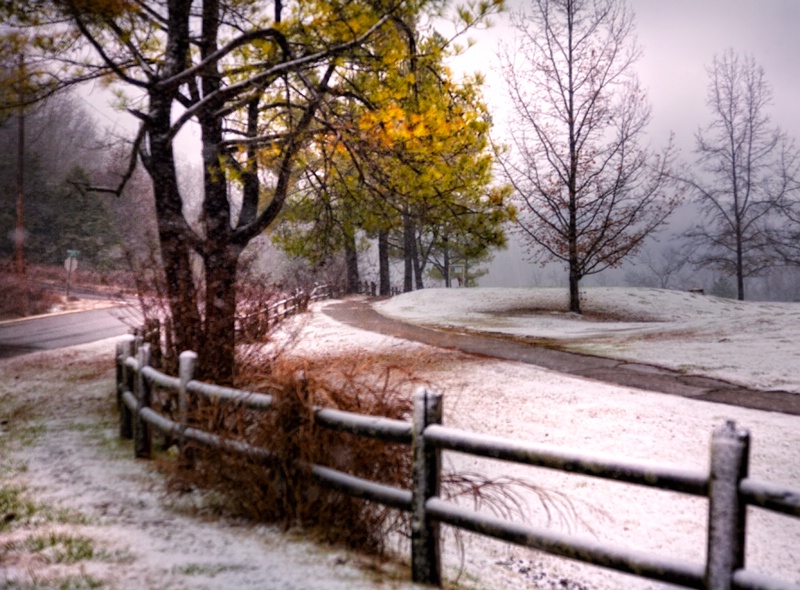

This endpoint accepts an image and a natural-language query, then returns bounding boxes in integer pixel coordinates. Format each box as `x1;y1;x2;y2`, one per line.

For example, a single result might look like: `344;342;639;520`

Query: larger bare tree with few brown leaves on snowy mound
503;0;678;312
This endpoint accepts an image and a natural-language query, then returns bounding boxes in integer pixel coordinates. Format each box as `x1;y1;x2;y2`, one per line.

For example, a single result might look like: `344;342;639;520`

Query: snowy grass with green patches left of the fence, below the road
0;340;424;590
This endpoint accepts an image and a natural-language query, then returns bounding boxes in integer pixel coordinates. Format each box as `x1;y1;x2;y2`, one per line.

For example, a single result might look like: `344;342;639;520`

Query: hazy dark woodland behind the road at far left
0;96;124;270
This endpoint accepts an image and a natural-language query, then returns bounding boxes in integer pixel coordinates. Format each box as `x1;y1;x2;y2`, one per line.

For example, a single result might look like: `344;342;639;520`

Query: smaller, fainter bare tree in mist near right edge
683;50;800;300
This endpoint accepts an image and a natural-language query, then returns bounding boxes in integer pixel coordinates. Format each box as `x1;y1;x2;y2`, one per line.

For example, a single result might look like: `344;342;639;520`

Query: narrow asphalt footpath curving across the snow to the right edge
324;300;800;416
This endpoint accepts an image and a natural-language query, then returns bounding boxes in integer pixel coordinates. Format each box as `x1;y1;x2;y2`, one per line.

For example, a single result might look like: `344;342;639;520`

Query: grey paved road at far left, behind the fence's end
0;307;136;358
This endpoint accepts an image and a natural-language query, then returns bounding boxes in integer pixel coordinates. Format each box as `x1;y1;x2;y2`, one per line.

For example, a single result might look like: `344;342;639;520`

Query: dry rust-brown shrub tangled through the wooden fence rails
155;351;580;553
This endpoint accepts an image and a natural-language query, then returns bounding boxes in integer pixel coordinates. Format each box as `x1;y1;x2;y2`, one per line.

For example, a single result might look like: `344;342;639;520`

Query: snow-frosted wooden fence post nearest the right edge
706;420;750;590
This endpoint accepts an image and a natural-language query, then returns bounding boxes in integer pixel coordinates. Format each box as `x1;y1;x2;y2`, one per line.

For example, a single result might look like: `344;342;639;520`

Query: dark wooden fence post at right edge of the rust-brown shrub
411;388;442;586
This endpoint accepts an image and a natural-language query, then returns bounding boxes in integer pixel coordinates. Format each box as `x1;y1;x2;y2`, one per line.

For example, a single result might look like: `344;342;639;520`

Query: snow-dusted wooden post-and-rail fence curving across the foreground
116;337;800;590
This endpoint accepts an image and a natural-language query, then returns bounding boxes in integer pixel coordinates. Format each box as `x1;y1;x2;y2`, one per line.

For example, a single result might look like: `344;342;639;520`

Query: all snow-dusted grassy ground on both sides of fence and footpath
0;289;800;590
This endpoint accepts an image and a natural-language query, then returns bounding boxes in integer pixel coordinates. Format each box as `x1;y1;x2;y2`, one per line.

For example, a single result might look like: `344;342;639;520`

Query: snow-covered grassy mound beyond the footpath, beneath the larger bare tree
375;287;800;393
